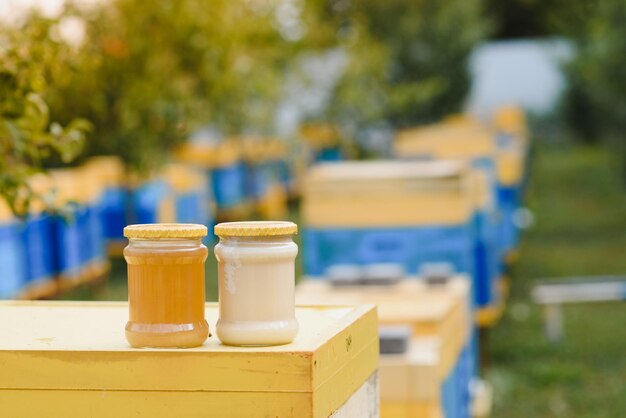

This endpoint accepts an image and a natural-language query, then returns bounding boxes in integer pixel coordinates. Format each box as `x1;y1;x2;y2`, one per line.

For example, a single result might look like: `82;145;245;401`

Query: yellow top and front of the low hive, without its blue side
296;276;472;418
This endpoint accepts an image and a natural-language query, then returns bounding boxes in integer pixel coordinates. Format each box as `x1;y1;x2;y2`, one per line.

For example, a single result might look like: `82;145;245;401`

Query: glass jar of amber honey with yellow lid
124;224;209;348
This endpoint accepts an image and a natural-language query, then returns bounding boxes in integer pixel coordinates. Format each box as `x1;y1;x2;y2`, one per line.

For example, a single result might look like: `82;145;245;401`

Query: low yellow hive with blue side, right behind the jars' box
296;276;477;418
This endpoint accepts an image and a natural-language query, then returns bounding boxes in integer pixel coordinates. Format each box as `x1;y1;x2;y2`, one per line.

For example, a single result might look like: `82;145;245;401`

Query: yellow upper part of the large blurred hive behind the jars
302;161;474;227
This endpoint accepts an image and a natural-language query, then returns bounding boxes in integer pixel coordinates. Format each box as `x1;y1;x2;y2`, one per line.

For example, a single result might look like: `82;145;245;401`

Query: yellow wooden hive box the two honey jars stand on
0;302;378;418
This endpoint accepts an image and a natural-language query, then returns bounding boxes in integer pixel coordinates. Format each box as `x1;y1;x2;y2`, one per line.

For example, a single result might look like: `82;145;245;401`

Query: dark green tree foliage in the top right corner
552;0;626;141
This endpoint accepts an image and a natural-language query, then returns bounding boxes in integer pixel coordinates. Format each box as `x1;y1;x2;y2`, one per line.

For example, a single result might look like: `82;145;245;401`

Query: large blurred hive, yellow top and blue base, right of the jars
302;161;476;304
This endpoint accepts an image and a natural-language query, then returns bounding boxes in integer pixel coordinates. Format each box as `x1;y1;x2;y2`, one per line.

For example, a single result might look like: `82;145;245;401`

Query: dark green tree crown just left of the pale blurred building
308;0;489;127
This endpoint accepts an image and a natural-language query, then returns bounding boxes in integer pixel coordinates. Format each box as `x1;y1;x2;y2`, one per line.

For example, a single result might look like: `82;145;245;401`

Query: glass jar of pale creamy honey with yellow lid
215;222;298;346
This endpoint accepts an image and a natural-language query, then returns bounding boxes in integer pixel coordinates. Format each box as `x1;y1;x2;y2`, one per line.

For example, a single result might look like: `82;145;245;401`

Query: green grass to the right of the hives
57;145;626;418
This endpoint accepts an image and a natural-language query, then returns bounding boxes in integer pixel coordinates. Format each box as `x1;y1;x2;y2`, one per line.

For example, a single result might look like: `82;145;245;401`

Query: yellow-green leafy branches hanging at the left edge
0;20;90;215
